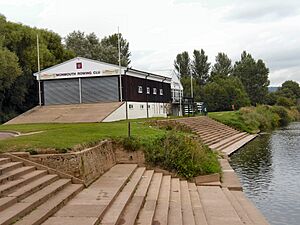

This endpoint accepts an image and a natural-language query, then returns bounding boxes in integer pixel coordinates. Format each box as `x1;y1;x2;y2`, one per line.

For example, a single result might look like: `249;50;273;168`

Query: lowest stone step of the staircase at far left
14;184;84;225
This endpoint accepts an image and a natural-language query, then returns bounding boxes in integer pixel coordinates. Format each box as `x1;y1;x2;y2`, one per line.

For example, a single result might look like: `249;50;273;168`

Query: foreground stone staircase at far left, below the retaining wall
0;157;83;225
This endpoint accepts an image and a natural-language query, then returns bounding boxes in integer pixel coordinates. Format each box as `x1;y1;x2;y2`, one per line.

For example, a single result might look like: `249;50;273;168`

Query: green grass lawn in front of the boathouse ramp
0;120;166;152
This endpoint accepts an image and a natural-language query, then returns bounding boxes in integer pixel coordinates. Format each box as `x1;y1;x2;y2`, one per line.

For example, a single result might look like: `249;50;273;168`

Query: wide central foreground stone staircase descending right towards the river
40;164;268;225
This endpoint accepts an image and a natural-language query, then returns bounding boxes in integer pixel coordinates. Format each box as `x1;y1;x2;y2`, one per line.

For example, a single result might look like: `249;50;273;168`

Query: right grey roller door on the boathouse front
81;76;119;103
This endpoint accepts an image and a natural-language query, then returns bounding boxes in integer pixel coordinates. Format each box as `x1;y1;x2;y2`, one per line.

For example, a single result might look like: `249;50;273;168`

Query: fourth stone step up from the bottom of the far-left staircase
0;170;47;197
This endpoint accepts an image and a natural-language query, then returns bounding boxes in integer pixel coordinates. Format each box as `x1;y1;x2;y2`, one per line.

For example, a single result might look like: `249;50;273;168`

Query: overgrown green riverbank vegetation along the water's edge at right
208;105;300;134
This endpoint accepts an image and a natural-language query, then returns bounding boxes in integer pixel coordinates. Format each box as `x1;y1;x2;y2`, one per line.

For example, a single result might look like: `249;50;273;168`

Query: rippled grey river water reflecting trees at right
230;122;300;225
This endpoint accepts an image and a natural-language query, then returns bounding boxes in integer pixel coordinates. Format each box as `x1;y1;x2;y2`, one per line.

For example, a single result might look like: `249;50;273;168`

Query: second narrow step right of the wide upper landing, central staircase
118;170;154;225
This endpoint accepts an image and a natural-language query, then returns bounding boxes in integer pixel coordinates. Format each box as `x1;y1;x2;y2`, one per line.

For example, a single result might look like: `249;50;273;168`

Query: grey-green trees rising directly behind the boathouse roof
65;31;131;66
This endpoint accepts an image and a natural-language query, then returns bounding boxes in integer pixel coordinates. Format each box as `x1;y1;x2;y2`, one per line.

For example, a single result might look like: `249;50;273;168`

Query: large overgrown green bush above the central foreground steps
145;132;221;178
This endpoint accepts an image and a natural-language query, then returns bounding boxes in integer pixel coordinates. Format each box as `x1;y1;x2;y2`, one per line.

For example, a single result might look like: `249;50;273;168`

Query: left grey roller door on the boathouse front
44;79;80;105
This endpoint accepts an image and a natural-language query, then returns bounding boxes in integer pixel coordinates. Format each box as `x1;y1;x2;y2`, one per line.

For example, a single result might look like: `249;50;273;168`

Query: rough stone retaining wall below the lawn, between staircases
28;140;144;185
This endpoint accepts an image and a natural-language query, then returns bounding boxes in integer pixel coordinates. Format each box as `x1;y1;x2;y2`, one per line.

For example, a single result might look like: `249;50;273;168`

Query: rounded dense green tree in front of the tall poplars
202;77;250;111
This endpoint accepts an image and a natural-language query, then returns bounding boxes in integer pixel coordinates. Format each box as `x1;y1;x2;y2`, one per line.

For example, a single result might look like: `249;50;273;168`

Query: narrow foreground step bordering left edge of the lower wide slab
188;183;208;225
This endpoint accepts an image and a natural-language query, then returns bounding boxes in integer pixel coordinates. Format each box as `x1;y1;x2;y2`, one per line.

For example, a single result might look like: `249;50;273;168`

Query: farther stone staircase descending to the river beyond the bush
176;116;256;155
